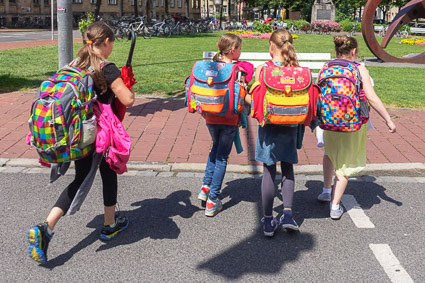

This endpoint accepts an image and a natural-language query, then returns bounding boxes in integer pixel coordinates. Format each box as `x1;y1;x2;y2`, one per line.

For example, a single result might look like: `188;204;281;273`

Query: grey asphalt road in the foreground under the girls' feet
0;168;425;282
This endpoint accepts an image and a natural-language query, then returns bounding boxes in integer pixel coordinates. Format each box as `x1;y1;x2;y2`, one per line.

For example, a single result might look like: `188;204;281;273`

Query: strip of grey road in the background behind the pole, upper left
0;30;81;43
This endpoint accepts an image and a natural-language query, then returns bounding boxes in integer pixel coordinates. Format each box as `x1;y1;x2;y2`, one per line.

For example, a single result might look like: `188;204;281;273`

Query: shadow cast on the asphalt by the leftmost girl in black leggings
45;190;199;269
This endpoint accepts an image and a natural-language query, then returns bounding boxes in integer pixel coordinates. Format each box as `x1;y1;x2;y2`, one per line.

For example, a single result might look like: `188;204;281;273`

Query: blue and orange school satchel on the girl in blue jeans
186;61;246;115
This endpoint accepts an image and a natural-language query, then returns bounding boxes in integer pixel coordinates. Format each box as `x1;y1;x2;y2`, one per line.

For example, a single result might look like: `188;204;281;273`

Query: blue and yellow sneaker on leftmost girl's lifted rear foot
27;222;53;264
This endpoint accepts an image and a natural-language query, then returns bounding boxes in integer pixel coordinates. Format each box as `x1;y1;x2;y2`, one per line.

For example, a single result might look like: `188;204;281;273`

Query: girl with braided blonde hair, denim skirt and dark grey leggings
246;30;304;237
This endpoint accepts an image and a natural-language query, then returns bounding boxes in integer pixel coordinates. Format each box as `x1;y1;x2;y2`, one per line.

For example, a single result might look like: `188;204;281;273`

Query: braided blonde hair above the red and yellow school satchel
270;29;299;67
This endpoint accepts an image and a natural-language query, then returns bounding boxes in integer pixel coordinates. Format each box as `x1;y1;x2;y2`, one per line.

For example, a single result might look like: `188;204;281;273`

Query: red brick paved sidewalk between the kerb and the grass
0;92;425;165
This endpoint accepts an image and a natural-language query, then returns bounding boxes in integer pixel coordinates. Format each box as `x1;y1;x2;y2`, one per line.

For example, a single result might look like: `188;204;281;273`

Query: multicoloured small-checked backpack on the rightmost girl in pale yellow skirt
318;59;369;132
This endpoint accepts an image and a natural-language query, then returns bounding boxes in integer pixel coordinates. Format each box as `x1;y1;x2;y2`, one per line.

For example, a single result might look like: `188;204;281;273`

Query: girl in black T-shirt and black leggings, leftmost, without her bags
27;22;134;264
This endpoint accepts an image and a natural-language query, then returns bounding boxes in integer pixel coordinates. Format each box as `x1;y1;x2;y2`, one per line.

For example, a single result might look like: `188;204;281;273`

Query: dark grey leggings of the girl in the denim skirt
261;162;295;216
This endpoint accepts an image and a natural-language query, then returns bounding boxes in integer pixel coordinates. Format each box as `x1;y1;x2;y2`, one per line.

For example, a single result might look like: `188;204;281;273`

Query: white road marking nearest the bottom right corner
369;244;413;283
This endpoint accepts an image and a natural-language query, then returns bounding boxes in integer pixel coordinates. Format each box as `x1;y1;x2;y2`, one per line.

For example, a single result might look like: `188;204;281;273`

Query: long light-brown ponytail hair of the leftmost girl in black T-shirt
75;22;115;94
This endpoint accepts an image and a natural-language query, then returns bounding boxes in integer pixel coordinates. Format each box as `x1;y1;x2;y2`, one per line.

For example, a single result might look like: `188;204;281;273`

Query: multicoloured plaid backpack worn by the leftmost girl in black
28;66;97;163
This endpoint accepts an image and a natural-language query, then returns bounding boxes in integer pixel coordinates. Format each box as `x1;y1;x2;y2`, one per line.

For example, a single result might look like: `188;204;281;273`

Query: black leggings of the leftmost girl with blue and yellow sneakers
54;154;118;215
